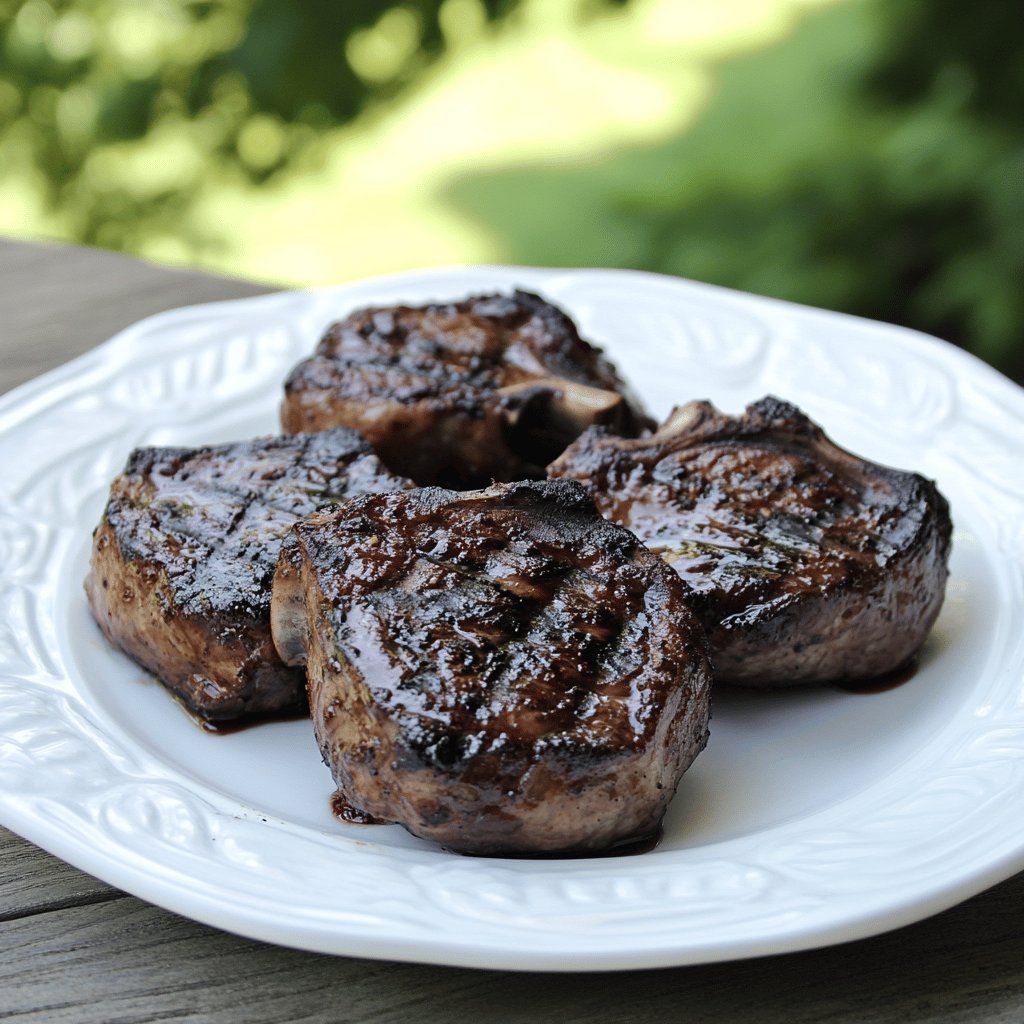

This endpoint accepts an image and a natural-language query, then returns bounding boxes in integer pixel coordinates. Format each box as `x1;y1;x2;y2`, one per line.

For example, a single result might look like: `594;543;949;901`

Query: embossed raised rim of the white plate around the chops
0;267;1024;970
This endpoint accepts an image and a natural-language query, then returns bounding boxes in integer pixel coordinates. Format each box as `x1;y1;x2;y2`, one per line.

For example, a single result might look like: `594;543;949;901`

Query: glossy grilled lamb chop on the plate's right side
549;397;951;686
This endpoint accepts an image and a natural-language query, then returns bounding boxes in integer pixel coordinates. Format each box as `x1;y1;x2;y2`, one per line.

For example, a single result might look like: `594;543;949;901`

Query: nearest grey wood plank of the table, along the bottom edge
0;878;1024;1024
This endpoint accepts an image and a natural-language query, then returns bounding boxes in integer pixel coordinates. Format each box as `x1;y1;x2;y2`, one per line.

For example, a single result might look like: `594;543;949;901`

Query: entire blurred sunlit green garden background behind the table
0;0;1024;381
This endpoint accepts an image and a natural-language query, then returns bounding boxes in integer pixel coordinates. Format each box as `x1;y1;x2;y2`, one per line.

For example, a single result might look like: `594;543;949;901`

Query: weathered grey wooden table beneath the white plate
0;242;1024;1024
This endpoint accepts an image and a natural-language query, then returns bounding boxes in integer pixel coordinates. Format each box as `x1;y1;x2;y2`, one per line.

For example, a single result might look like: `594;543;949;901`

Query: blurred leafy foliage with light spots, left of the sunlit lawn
0;0;536;251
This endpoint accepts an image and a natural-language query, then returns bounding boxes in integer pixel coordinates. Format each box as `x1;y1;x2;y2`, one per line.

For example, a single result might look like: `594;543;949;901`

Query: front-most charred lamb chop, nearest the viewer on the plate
271;481;710;854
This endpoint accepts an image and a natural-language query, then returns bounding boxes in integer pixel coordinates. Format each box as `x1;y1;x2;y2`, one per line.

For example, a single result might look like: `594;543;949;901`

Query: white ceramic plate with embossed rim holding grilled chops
0;267;1024;970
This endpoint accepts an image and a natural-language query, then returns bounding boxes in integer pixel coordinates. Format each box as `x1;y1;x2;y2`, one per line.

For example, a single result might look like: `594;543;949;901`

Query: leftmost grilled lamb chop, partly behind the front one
85;429;412;722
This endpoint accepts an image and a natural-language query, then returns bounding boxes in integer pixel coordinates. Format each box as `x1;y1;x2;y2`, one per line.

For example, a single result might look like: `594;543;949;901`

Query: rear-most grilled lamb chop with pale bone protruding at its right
282;292;652;487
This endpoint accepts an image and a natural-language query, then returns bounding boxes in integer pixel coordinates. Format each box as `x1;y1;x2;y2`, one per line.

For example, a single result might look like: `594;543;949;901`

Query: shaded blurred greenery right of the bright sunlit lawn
456;0;1024;383
